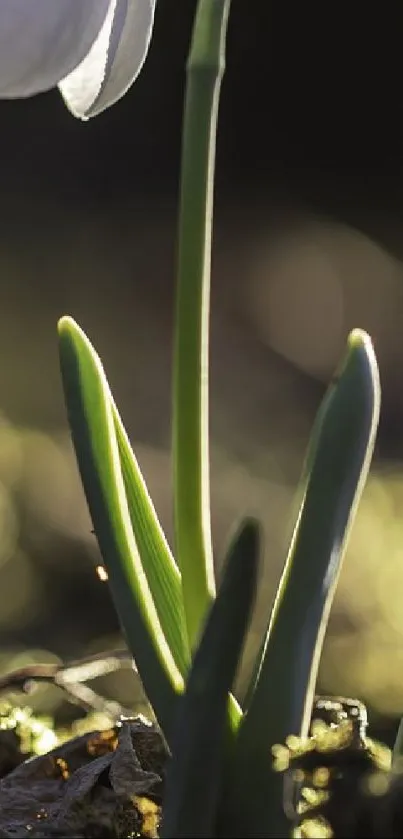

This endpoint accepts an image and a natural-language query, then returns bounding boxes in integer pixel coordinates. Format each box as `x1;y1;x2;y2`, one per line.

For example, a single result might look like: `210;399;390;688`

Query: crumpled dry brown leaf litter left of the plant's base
0;717;166;839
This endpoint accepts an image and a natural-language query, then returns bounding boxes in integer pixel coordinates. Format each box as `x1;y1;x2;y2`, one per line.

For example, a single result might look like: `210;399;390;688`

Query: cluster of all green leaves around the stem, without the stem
59;318;380;836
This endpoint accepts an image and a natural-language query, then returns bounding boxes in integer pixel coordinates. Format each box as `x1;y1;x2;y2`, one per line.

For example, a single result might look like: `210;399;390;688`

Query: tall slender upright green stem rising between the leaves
173;0;230;649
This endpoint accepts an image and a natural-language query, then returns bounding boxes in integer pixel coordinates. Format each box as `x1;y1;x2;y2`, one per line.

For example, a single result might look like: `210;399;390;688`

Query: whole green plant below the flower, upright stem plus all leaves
59;0;388;839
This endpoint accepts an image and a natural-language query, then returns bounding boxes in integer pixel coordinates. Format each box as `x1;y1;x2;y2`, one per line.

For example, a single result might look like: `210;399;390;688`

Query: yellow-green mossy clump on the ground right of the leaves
273;697;394;839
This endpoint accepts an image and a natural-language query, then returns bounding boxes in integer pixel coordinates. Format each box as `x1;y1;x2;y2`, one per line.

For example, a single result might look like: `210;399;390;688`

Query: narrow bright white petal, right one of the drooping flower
58;0;156;119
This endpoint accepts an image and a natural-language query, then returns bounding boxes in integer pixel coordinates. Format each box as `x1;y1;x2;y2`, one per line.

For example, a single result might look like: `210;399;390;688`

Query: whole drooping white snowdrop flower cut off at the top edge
0;0;156;119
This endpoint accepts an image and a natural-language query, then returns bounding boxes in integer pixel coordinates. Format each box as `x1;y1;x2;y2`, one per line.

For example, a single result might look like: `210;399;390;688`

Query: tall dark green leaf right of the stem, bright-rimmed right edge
226;330;380;837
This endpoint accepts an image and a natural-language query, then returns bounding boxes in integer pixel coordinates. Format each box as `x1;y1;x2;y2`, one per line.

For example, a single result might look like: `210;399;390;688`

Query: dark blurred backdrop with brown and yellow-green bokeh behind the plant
0;0;403;742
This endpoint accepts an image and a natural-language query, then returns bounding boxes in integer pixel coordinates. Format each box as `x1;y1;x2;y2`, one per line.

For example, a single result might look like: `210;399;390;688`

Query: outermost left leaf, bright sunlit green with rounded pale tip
59;317;184;742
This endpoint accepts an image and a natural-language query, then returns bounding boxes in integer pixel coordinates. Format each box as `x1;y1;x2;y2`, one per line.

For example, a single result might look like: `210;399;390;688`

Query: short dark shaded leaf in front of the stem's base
160;520;259;839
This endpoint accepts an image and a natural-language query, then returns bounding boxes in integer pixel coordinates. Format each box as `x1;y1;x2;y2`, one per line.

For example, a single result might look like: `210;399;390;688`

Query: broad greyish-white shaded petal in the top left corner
0;0;110;98
